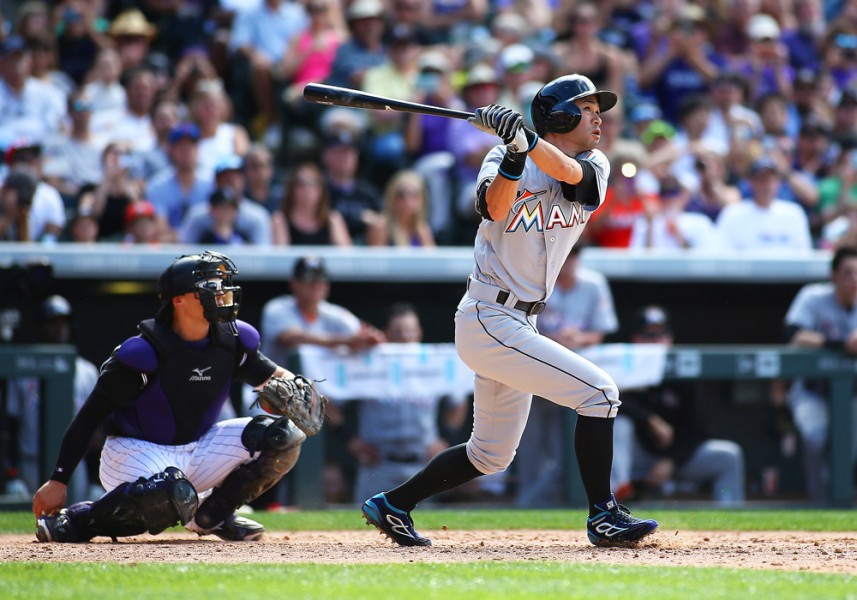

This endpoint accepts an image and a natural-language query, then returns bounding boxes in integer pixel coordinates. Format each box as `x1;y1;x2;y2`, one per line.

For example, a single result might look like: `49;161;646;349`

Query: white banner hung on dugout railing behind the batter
300;344;667;400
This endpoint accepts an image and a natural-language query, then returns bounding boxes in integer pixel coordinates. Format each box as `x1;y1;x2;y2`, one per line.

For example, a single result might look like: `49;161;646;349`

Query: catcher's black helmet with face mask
155;250;241;335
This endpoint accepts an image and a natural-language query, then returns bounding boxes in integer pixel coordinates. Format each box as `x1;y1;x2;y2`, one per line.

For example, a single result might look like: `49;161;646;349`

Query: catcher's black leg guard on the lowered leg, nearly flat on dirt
63;467;199;542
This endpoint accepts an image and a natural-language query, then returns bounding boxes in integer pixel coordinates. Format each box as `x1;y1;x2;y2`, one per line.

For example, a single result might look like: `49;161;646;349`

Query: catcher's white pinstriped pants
99;417;258;496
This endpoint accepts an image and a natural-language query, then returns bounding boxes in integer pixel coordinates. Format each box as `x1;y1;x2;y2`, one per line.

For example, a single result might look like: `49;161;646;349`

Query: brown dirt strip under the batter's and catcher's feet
0;528;857;575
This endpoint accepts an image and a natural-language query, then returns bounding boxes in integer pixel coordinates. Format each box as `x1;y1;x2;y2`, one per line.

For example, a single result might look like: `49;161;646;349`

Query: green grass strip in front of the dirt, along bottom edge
0;562;857;600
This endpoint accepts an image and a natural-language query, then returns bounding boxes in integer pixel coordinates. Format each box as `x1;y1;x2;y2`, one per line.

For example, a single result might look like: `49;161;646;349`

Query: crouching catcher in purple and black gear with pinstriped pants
33;252;327;542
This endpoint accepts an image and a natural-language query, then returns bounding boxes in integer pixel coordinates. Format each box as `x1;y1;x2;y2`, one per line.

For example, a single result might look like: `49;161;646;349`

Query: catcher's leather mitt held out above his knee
250;375;327;436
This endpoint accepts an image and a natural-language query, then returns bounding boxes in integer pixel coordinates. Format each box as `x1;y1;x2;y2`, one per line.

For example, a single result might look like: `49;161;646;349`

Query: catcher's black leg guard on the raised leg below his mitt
195;415;306;529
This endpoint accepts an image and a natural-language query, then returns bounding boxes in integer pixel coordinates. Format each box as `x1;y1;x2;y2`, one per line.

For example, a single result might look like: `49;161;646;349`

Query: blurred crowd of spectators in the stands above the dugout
5;0;857;252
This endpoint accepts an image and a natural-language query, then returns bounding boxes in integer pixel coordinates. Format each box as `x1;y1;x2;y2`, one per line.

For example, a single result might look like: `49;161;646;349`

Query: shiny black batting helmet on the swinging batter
530;75;618;135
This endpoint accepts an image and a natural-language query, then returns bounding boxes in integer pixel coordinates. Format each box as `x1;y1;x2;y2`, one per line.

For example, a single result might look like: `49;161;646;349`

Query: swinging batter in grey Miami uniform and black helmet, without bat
363;75;658;546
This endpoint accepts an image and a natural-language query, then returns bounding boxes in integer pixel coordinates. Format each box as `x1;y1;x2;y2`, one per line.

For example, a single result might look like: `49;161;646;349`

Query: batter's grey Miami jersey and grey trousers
455;146;620;474
